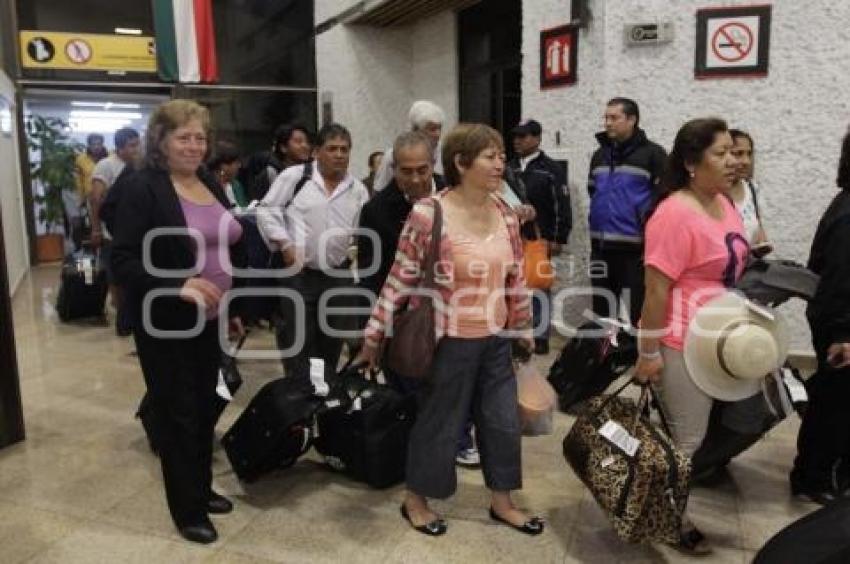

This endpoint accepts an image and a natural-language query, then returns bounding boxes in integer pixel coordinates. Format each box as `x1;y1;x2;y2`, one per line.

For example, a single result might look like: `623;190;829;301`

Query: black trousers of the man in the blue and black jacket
590;241;644;325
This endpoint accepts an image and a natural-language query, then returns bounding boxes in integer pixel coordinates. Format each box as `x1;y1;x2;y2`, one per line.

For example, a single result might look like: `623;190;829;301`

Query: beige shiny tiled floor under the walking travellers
0;267;814;564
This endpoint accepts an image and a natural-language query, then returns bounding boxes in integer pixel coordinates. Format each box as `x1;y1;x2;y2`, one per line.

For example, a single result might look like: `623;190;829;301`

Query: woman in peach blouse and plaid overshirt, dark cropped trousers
360;124;543;536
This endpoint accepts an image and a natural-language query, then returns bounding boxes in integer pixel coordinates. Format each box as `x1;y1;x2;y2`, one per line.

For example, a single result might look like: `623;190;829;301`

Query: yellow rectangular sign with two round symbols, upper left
20;30;156;72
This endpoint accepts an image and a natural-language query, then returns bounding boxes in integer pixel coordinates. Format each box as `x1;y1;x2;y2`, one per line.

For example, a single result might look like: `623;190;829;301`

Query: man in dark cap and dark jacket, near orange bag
508;119;572;354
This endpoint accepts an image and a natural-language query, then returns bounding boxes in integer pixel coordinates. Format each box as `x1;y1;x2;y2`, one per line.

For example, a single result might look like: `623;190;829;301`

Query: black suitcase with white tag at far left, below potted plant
56;249;109;322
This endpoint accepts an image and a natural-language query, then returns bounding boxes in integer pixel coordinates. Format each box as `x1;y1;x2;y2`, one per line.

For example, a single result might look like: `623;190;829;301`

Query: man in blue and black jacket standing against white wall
587;98;667;324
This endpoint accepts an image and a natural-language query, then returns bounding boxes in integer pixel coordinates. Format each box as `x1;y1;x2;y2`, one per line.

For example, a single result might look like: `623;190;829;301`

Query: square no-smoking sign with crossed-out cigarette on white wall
694;6;771;78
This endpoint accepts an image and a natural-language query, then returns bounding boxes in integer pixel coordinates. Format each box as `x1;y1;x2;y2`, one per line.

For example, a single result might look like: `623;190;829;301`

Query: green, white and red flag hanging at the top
153;0;218;82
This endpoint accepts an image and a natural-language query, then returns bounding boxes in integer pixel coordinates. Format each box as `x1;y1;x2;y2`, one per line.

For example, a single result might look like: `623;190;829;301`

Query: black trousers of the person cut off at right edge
793;347;850;488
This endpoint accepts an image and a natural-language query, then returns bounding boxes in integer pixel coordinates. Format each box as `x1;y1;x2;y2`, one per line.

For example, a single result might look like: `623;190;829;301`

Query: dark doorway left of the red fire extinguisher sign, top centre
458;0;522;156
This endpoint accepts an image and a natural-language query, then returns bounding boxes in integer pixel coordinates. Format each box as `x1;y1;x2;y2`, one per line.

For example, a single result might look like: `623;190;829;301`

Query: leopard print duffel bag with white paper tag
564;384;691;543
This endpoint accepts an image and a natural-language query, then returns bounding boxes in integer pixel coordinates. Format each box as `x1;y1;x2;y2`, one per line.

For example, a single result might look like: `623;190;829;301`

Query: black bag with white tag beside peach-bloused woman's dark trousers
315;370;416;488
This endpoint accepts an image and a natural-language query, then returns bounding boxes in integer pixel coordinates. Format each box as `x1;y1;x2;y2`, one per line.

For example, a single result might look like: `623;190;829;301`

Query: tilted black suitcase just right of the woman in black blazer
221;378;325;482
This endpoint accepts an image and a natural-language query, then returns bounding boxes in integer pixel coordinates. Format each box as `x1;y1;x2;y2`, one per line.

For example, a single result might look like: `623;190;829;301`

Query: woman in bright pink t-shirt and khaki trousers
635;118;749;554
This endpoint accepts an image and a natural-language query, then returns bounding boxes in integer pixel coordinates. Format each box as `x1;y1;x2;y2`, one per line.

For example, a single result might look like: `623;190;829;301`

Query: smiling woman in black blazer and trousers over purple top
112;100;242;543
